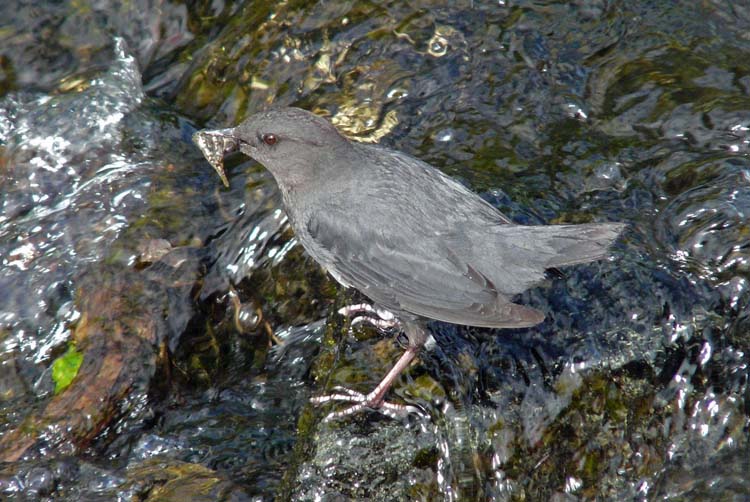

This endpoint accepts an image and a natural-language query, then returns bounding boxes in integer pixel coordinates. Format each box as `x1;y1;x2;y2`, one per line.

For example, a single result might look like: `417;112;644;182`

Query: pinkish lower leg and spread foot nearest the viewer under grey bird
310;320;427;422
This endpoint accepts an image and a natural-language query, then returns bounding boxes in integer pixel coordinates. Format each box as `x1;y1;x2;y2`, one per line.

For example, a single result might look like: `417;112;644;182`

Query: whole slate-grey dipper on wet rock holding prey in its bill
193;108;624;419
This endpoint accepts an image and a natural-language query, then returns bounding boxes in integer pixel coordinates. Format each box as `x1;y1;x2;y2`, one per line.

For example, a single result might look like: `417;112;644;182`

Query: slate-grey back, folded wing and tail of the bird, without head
302;145;622;327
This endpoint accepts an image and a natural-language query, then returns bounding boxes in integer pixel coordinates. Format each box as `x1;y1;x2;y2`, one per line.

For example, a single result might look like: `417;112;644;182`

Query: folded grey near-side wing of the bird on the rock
306;207;544;328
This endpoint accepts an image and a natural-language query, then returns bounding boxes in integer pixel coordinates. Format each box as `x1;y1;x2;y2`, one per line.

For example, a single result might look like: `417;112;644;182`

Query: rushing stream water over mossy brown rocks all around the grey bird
0;1;750;500
